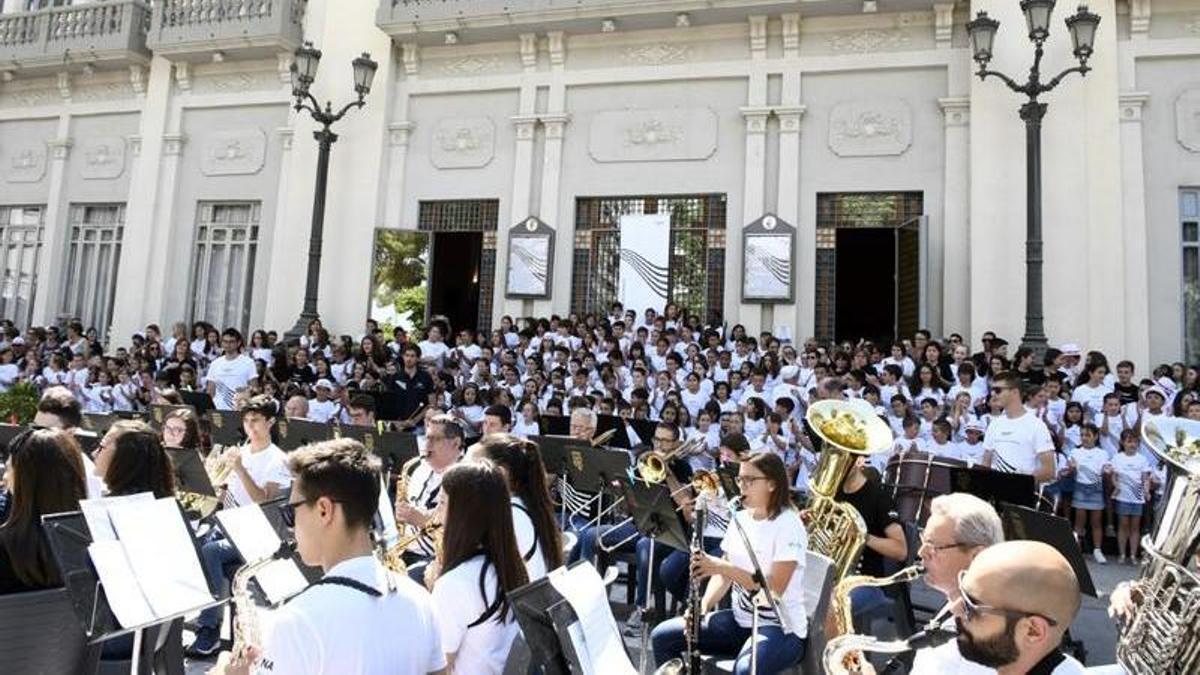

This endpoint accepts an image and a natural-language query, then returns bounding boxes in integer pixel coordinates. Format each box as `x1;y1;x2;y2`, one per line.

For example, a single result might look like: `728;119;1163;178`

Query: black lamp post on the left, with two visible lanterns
284;42;379;341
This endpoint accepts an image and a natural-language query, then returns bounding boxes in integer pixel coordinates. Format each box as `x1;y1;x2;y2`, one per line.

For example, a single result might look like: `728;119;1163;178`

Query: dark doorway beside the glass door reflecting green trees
430;232;484;331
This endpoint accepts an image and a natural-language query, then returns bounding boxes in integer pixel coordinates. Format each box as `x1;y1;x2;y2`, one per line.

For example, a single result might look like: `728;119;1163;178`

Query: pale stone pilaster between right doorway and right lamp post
926;97;973;340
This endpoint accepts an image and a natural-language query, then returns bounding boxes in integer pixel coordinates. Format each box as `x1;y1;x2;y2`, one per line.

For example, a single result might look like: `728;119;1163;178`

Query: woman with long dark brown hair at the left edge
0;429;88;595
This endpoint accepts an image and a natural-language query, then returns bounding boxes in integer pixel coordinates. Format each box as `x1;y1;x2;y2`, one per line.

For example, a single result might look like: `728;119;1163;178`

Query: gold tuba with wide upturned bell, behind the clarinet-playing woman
800;400;892;579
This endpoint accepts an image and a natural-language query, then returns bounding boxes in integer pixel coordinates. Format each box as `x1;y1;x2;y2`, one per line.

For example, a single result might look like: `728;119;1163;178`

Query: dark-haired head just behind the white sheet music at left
96;420;175;498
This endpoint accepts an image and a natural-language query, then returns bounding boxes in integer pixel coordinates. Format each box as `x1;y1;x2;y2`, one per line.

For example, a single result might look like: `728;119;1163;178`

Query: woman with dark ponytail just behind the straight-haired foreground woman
469;434;563;581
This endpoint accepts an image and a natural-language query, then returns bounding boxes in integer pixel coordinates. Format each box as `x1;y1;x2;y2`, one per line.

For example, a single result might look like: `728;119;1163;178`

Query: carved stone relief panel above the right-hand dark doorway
829;98;912;157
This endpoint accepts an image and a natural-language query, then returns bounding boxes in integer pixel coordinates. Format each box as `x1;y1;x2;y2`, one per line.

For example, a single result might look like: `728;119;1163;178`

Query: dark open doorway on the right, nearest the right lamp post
834;227;896;345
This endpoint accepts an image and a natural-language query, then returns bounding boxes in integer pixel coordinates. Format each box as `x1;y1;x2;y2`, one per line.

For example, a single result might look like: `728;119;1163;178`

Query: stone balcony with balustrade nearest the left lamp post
146;0;307;56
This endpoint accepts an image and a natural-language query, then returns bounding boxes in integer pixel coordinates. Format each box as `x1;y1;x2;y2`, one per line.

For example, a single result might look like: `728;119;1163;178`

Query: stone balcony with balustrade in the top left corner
0;0;150;71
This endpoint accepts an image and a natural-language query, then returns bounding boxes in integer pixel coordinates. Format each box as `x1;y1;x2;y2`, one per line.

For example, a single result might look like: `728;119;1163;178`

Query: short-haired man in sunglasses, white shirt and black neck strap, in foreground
215;438;446;675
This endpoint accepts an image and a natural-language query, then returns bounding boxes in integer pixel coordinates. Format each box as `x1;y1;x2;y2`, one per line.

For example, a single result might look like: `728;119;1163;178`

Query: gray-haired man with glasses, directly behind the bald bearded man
912;492;1004;675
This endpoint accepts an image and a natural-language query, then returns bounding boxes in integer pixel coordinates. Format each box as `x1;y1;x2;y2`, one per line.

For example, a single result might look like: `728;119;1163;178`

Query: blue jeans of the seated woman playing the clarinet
650;609;805;675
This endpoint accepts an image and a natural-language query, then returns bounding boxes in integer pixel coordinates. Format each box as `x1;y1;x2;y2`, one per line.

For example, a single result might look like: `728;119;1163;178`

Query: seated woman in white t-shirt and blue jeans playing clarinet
650;453;808;674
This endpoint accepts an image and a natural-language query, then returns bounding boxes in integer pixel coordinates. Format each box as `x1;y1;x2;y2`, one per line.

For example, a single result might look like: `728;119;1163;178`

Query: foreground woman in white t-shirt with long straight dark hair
427;461;529;675
